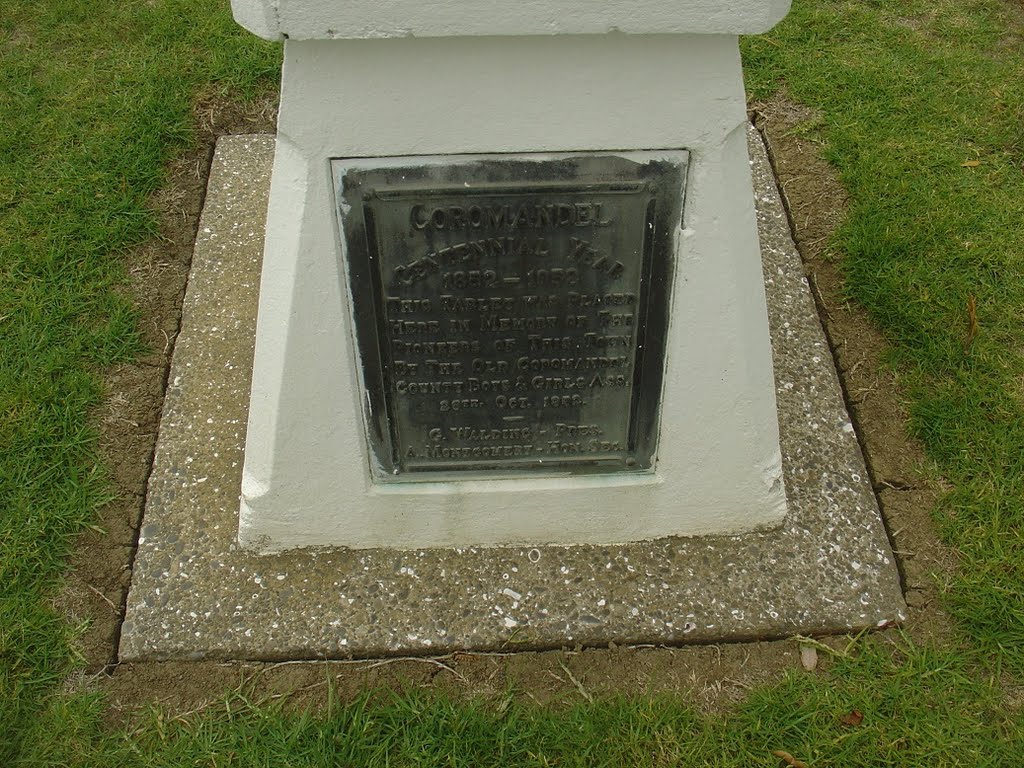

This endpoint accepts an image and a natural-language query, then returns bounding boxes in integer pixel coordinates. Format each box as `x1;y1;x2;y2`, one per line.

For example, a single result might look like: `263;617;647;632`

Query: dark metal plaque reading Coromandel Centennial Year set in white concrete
333;151;687;480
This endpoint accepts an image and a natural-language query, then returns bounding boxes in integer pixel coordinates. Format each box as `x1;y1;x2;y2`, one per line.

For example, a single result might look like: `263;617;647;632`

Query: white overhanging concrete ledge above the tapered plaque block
231;0;791;40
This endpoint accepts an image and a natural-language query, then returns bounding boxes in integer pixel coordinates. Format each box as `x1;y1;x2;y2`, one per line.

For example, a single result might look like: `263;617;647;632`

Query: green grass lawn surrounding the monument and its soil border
0;0;1024;766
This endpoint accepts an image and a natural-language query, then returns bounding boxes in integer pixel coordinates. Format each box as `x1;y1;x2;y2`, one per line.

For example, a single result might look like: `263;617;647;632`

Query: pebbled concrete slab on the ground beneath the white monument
120;129;905;660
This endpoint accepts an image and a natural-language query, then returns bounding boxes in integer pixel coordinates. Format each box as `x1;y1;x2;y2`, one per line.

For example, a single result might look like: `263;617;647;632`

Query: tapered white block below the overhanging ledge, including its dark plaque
239;33;786;554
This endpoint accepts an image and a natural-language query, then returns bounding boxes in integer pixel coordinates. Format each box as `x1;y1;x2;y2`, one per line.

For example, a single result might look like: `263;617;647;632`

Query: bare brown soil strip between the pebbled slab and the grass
61;95;954;721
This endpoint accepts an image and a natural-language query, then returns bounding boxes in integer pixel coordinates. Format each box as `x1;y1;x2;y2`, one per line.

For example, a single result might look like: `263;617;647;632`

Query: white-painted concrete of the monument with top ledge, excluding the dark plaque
232;0;788;551
